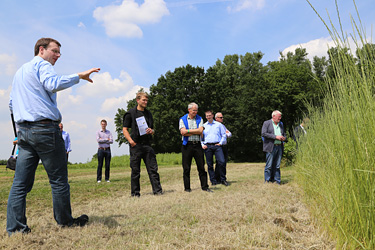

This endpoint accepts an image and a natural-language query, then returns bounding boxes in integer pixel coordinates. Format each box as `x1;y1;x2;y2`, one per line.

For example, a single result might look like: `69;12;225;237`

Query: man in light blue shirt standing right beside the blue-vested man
202;110;229;186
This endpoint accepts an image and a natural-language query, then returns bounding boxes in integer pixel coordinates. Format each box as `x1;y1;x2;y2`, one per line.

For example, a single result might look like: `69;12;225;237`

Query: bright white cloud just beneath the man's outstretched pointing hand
78;71;133;98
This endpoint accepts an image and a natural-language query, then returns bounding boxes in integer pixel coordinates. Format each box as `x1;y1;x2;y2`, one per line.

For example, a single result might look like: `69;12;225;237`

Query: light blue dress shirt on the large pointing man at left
9;56;79;123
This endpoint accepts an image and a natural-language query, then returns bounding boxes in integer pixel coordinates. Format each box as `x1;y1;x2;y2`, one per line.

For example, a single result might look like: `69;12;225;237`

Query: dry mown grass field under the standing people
0;157;335;250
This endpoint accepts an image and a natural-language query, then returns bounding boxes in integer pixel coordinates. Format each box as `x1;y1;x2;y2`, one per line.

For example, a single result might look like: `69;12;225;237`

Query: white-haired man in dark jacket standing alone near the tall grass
262;110;286;185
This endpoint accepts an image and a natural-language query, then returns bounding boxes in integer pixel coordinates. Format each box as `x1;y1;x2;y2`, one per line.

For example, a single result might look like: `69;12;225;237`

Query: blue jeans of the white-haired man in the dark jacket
264;145;283;184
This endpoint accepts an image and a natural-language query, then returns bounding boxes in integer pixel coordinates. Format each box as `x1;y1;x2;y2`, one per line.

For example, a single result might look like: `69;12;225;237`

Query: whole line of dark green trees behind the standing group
115;44;374;162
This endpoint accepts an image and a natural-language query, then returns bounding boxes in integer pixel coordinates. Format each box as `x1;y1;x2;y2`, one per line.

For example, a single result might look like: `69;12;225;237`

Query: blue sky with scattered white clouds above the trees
0;0;375;162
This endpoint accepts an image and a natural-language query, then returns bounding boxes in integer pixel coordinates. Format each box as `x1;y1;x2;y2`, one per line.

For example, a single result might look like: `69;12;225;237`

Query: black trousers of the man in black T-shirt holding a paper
129;143;162;195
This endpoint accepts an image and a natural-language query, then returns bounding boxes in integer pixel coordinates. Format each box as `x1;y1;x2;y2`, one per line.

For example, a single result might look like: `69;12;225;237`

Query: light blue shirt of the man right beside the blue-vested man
202;120;227;145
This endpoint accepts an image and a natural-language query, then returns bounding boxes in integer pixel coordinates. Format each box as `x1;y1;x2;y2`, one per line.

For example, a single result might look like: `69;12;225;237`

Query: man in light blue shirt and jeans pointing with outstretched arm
6;38;100;235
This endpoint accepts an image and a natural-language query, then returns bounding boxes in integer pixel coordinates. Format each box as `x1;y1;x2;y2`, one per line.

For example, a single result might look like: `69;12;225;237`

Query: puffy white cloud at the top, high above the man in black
93;0;169;37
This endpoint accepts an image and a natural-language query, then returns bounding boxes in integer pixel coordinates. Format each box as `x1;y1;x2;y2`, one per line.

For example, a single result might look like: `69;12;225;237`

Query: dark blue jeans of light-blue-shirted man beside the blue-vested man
204;145;226;184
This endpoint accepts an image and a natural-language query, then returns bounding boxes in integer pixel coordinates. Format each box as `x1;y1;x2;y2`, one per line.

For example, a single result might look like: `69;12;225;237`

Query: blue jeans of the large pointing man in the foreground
6;122;73;235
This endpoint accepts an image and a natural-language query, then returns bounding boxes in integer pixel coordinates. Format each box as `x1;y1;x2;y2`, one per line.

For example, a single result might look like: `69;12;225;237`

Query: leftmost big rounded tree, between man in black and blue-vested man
149;64;205;153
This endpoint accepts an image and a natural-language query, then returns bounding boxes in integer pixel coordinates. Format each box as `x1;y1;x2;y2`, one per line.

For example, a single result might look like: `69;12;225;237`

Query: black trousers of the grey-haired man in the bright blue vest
181;142;208;190
